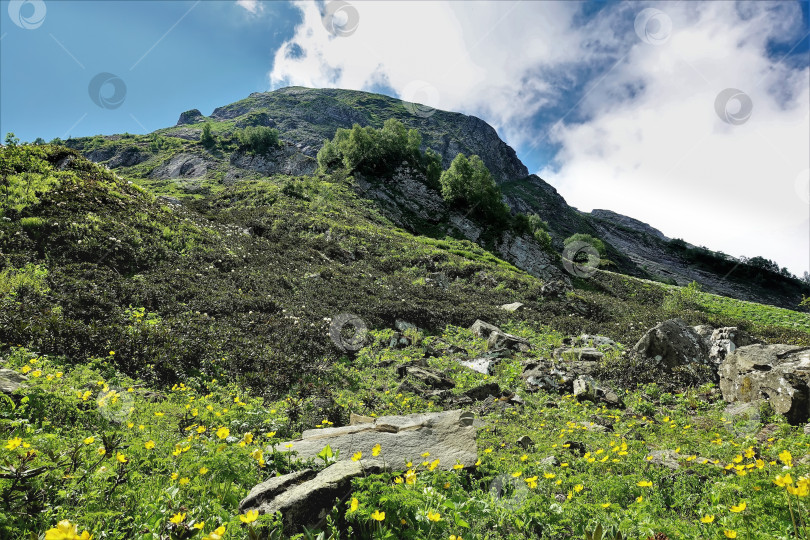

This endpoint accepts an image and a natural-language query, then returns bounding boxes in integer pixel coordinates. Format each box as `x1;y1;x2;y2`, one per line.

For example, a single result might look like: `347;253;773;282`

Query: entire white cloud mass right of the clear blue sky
269;1;810;273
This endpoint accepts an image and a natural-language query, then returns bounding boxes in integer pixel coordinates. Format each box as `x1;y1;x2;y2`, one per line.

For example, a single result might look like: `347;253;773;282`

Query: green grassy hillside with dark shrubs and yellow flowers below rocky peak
0;146;810;540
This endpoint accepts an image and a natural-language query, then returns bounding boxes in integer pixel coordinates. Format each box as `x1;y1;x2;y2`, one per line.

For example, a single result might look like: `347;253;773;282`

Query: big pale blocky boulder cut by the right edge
719;344;810;424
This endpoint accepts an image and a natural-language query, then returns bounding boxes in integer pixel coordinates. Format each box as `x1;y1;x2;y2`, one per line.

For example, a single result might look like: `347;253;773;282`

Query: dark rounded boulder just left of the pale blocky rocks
633;319;709;370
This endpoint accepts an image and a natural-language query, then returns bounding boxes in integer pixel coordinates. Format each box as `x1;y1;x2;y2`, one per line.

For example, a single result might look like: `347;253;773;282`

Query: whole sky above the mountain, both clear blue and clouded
0;0;810;274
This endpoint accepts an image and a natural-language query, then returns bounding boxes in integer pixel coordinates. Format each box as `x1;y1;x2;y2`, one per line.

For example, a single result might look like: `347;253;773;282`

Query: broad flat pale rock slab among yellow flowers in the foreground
276;410;478;470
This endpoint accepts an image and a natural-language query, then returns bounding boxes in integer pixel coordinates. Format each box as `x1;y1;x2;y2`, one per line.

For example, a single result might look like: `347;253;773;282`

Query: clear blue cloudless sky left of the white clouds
0;0;301;140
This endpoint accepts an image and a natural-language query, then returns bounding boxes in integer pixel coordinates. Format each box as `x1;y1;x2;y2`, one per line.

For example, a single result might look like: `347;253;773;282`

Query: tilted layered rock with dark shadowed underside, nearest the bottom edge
239;460;384;532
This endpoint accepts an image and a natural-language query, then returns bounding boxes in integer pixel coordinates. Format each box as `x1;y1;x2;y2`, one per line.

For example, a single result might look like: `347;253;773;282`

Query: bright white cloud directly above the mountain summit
270;1;579;143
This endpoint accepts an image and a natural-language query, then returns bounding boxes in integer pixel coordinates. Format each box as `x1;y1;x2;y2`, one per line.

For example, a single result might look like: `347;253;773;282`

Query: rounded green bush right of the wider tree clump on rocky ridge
440;154;509;221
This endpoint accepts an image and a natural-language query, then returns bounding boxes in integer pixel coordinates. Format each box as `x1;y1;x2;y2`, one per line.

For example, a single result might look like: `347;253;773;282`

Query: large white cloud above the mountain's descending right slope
539;2;810;275
